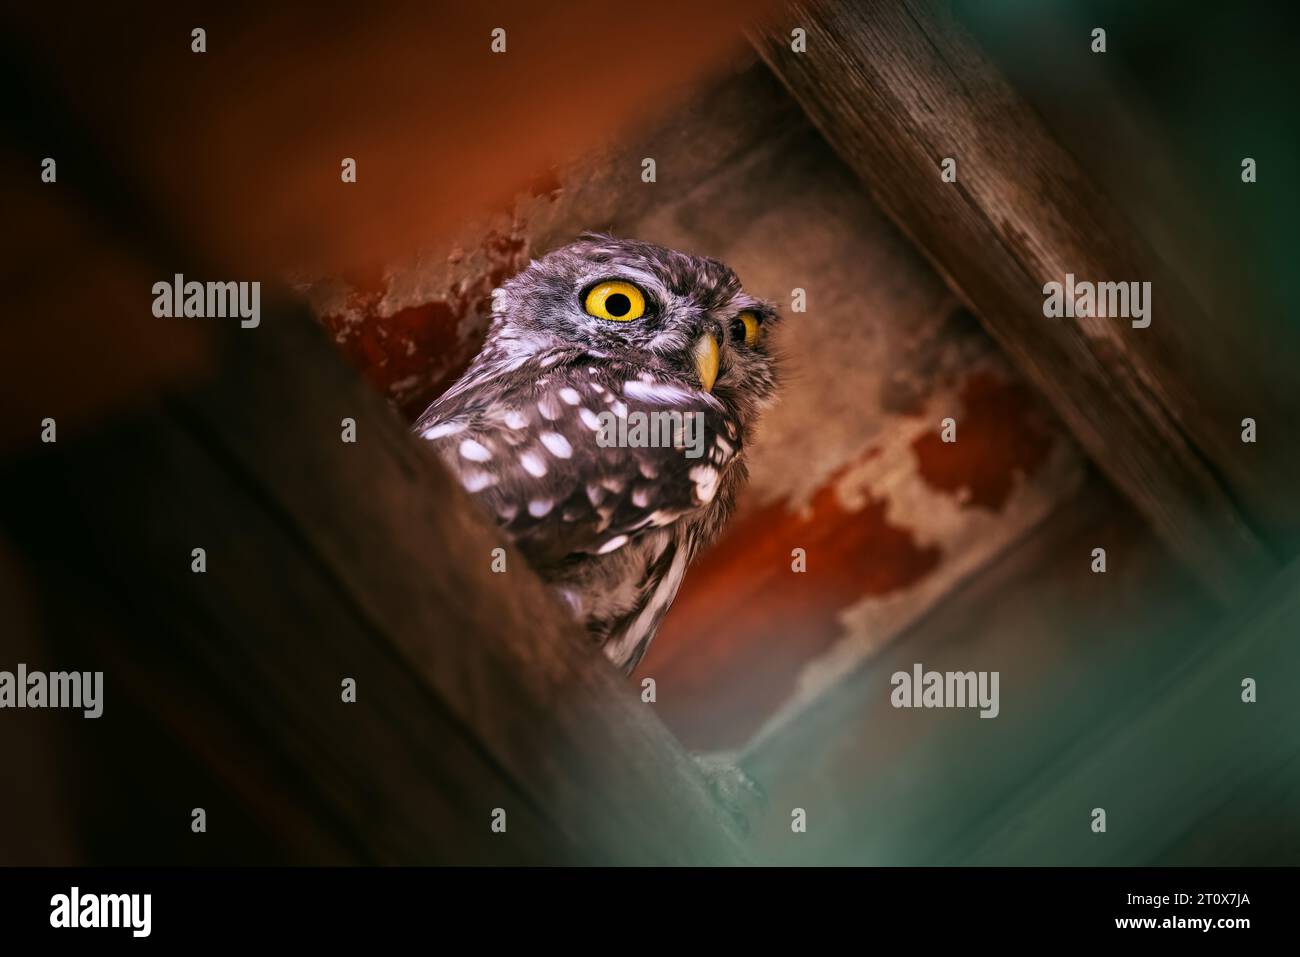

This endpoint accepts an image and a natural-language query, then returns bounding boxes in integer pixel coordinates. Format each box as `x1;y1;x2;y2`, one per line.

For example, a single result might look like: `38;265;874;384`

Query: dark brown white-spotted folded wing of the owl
415;354;740;566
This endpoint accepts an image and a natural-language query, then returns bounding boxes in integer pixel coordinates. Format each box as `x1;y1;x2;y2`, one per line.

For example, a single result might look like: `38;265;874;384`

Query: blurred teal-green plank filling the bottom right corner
950;548;1300;865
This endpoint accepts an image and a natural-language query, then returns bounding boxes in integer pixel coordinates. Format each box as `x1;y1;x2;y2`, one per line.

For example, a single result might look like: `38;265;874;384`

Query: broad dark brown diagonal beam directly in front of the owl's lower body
4;304;742;863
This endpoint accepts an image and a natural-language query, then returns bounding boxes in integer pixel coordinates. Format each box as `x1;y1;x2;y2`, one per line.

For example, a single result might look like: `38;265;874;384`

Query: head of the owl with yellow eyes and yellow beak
486;233;777;420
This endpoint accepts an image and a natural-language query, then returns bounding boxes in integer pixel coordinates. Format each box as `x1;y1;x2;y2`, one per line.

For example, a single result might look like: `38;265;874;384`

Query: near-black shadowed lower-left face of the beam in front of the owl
3;413;569;863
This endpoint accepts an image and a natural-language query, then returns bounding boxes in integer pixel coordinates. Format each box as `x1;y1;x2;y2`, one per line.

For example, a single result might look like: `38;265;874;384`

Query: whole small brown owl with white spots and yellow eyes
415;234;776;672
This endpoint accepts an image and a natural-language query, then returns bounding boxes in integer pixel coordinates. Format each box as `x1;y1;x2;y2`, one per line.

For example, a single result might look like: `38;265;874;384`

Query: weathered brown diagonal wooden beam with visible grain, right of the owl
755;0;1278;602
